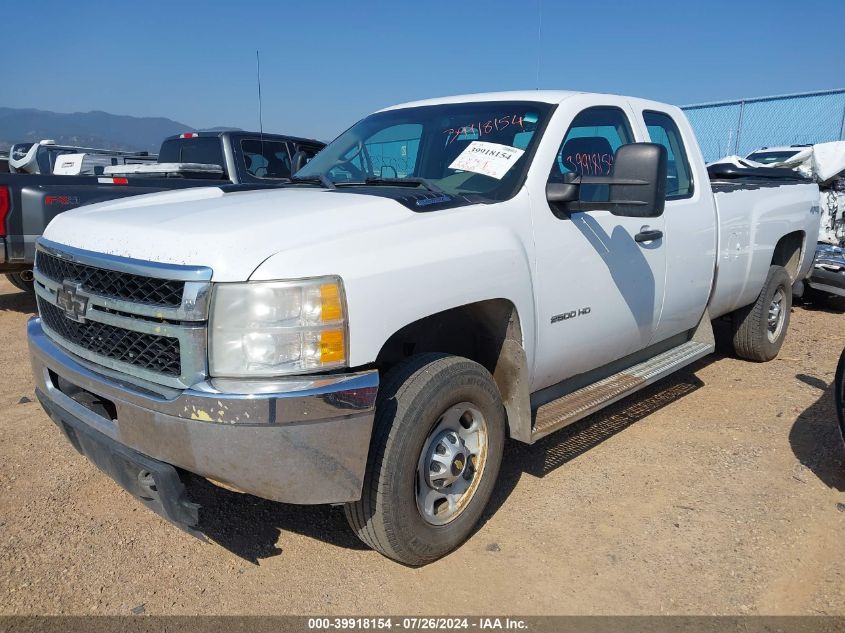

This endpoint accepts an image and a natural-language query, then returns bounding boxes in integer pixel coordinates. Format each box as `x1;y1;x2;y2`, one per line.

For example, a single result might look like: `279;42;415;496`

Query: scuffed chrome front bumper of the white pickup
27;317;378;504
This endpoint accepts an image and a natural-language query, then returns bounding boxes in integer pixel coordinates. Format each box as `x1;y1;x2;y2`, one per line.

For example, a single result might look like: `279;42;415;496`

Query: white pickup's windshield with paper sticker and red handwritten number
295;101;553;200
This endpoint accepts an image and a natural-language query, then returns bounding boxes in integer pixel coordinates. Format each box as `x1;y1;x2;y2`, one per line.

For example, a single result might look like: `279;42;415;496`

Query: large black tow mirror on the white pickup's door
546;143;667;218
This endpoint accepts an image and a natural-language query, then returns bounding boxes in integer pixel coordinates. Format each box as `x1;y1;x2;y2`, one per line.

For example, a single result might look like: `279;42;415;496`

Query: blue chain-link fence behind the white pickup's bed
682;89;845;161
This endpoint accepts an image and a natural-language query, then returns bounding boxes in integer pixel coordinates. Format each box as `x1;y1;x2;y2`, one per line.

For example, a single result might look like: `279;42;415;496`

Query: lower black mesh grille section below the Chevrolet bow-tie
38;297;182;376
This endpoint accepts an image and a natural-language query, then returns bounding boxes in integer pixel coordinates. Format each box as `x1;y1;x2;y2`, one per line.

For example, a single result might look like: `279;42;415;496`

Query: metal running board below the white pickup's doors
531;338;715;442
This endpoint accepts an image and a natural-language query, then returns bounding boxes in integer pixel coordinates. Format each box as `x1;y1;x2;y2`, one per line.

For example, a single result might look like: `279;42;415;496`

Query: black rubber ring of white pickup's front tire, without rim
380;359;505;560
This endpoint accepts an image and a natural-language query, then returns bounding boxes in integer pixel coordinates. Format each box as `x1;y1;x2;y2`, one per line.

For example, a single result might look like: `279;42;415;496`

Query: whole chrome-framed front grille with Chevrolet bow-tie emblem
33;238;212;389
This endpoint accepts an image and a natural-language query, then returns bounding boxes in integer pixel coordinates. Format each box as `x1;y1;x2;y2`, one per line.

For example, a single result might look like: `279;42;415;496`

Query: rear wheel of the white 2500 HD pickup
732;266;792;362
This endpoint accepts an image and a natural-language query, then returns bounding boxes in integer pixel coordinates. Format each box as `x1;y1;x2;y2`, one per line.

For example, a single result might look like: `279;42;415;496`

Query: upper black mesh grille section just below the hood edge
35;251;185;307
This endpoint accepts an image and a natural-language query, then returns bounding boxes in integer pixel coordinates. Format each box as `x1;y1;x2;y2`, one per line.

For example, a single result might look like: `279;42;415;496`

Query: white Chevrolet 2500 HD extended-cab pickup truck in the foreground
28;91;819;565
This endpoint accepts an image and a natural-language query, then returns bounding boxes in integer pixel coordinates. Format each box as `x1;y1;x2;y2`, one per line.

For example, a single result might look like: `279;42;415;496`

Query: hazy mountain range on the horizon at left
0;107;234;152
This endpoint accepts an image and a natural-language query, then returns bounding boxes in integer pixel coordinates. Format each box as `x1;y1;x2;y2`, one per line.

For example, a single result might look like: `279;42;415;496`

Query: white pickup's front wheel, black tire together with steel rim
345;354;505;566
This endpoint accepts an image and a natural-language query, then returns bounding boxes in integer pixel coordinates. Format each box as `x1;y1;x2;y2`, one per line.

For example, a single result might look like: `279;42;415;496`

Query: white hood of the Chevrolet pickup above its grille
44;187;416;281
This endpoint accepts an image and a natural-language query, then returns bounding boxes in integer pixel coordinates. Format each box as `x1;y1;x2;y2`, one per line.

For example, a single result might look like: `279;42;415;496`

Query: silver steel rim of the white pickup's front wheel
416;402;487;525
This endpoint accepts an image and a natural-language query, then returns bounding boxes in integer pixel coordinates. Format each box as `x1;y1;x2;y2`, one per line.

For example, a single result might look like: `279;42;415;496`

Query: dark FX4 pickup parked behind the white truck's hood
0;132;324;291
